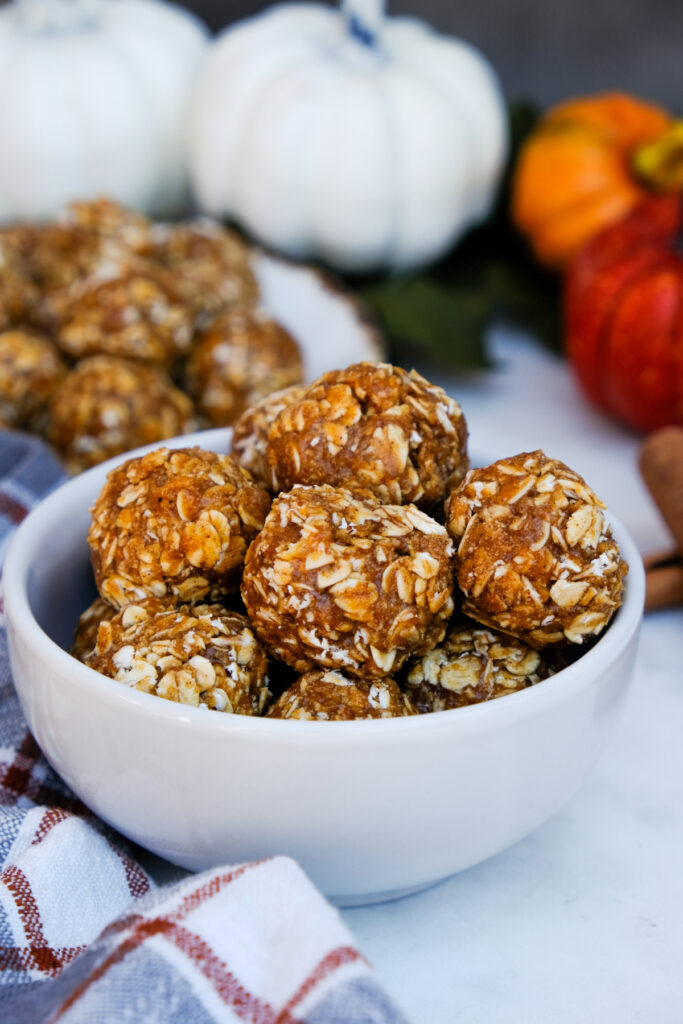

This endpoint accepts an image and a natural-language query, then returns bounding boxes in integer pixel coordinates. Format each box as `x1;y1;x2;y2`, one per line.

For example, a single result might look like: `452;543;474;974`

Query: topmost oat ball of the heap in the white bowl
266;362;468;510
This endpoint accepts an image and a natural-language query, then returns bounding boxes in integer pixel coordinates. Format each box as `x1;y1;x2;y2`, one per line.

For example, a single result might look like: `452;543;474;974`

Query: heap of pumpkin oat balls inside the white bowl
73;362;627;720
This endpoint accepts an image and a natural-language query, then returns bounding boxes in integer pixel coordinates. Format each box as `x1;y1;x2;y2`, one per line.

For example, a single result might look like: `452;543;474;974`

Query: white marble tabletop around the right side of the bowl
344;331;683;1024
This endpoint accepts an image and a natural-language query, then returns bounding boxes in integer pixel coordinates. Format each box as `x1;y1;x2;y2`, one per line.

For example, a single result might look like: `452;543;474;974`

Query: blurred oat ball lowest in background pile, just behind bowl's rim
46;355;196;473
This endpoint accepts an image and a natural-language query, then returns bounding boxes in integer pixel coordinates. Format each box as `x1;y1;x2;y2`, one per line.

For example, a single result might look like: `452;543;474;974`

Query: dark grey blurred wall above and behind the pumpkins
184;0;683;112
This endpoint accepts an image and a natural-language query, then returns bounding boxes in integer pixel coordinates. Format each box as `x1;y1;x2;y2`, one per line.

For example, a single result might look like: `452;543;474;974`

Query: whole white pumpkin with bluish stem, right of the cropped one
190;0;507;270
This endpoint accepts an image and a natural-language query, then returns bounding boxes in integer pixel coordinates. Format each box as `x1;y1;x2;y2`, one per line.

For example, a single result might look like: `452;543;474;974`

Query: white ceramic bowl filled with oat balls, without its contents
4;430;644;904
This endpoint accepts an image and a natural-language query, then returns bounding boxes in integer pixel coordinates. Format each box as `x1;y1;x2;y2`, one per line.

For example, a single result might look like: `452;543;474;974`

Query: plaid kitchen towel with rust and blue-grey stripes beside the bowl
0;431;404;1024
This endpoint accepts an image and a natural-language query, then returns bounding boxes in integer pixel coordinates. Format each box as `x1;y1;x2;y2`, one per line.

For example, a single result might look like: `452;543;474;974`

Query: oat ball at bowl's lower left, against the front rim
85;599;270;715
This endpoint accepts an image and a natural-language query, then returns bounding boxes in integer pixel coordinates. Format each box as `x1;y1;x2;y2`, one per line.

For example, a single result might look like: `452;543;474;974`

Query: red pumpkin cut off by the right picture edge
565;197;683;431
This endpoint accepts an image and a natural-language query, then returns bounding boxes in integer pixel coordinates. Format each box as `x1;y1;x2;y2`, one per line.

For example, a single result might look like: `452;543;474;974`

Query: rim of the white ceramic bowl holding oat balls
2;428;645;744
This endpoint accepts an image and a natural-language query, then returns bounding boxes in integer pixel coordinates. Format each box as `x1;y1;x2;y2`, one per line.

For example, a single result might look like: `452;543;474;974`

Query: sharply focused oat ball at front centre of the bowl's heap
242;485;453;679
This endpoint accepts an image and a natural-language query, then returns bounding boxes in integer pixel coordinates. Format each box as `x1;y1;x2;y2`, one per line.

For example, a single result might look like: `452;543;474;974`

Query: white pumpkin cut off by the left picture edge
0;0;207;220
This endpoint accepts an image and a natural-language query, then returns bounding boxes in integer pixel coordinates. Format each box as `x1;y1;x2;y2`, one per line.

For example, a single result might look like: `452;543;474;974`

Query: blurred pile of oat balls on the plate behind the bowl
0;200;302;473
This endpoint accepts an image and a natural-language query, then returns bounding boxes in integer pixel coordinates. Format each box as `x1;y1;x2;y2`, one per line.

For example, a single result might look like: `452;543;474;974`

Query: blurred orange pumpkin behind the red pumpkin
512;92;673;269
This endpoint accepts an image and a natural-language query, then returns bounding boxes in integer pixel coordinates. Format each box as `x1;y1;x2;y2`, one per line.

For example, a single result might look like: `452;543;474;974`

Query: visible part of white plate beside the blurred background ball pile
252;249;385;382
